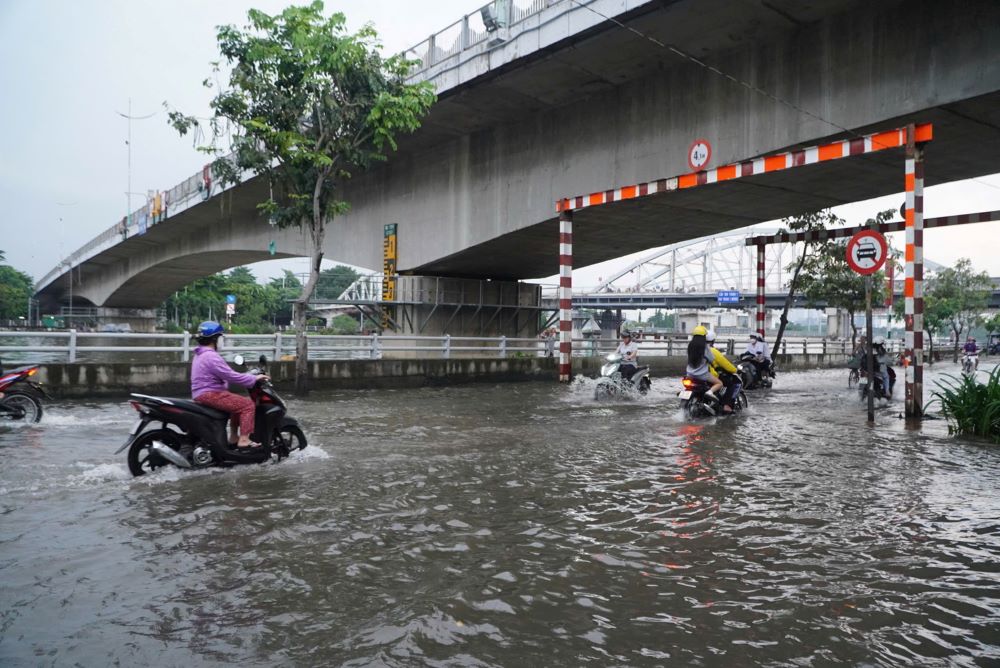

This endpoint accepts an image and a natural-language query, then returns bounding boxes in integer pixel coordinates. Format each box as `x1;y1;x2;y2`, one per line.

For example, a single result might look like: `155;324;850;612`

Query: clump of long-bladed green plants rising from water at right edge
933;366;1000;443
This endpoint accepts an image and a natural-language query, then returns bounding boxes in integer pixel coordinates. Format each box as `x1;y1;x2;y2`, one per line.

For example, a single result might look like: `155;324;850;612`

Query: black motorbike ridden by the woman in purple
115;355;307;476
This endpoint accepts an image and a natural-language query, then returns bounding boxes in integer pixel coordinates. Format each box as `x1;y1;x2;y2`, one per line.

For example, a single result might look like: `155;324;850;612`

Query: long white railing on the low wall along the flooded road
0;329;912;363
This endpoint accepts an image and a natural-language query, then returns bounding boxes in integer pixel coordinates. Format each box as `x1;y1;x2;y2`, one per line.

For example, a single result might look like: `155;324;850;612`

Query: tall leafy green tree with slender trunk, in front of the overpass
169;1;435;393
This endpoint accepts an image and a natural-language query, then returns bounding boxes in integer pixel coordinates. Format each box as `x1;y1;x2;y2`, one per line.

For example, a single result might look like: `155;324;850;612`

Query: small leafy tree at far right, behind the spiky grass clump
924;258;993;362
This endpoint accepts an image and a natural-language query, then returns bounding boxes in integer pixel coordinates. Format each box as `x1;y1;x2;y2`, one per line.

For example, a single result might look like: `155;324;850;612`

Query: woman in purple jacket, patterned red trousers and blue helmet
191;320;269;448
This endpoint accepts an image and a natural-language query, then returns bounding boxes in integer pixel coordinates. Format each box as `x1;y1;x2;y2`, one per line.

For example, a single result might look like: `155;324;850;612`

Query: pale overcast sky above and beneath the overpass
0;0;1000;285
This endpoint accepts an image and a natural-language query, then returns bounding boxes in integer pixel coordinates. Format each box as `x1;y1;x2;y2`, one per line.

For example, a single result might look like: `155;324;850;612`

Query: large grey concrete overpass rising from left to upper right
38;0;1000;324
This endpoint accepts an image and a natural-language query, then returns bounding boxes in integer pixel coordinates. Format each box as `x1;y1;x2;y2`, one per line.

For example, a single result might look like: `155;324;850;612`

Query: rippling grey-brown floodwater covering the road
0;365;1000;666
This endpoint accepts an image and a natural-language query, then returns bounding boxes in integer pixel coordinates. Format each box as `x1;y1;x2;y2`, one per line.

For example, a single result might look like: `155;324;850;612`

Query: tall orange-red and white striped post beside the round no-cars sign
903;125;924;417
